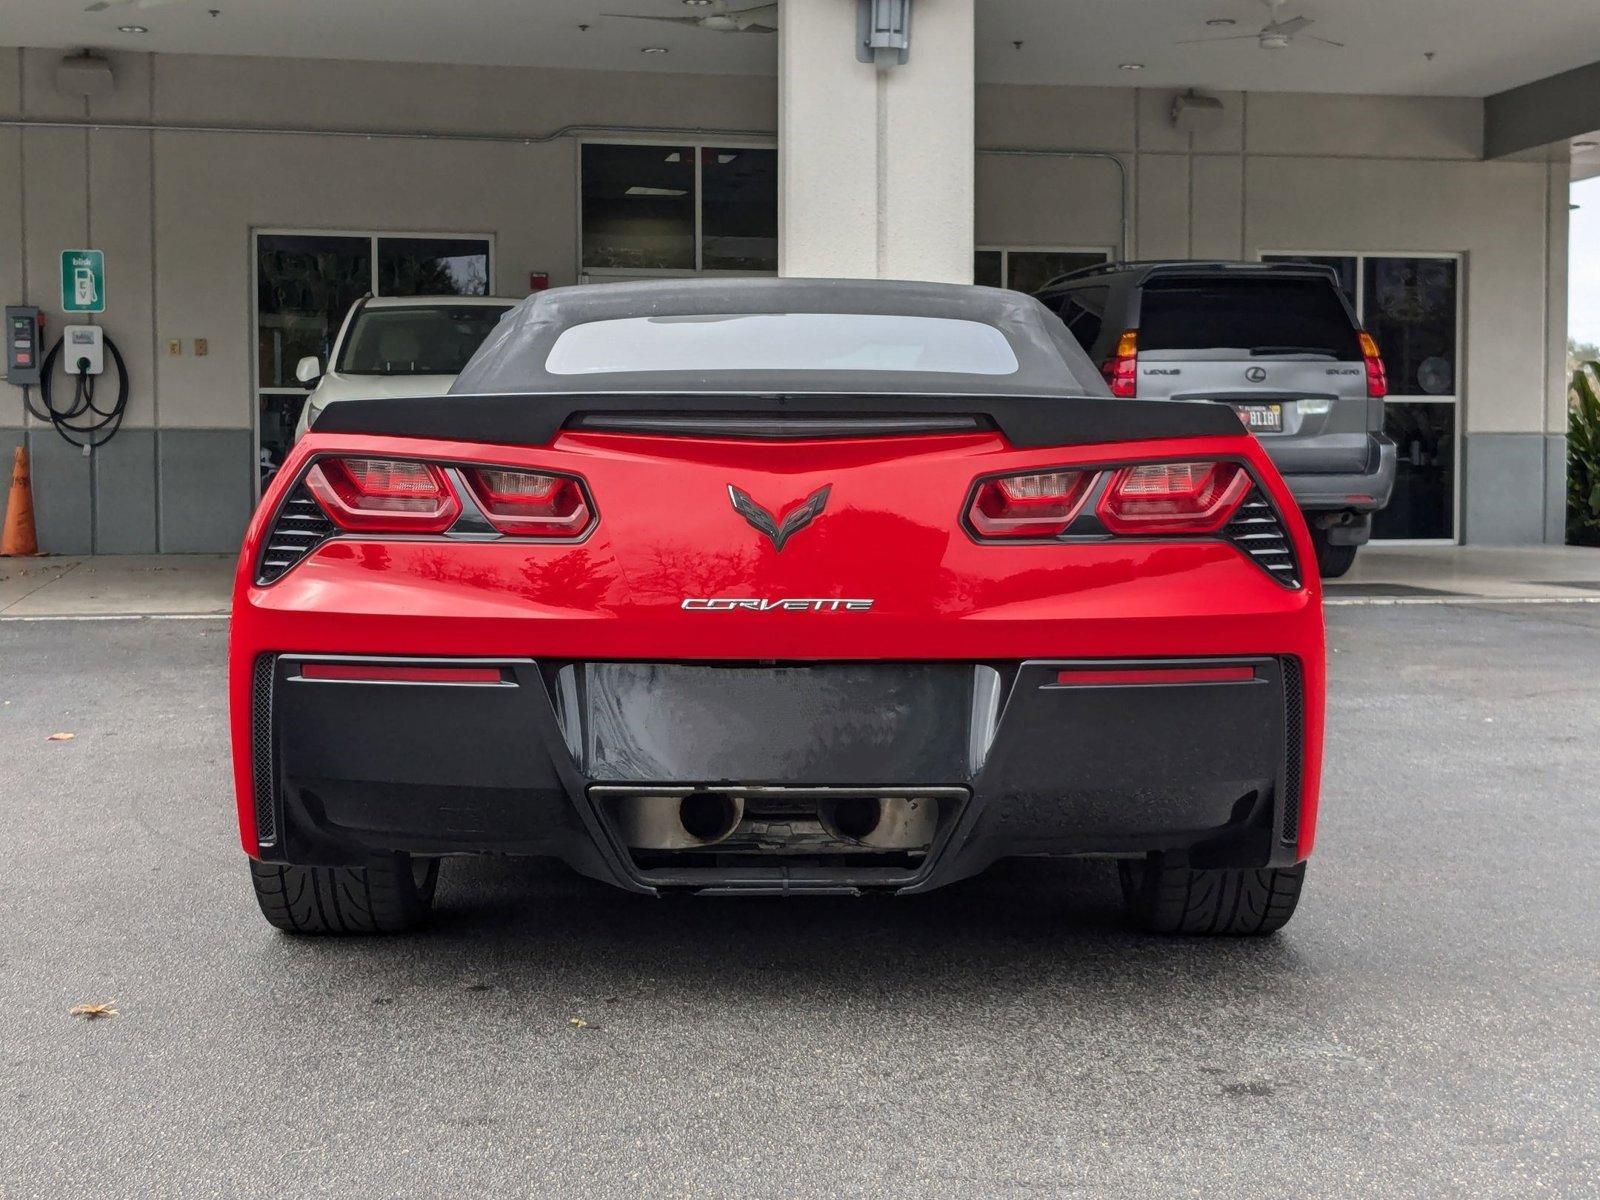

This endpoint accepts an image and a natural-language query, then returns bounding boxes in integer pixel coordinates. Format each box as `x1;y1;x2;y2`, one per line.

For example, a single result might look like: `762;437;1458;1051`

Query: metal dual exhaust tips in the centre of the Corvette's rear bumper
613;790;938;850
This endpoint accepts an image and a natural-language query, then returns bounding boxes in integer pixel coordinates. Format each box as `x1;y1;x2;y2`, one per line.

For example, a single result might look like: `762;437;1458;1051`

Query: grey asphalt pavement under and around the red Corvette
0;603;1600;1200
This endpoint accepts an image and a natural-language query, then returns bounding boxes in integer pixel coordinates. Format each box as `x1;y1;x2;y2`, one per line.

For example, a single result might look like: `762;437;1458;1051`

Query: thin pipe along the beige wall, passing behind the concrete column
0;117;1128;258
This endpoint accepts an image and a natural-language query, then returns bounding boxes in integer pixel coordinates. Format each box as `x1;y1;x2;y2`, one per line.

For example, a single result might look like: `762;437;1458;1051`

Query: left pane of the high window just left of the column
582;144;694;270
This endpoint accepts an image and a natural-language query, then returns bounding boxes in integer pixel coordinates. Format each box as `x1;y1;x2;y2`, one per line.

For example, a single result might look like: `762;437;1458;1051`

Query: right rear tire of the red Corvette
1117;854;1306;938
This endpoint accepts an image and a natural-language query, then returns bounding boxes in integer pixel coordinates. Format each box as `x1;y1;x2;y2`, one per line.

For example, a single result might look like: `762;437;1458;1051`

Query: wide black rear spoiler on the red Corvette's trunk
312;392;1245;446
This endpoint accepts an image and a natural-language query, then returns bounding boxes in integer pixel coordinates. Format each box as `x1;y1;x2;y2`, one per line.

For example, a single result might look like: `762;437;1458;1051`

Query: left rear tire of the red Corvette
250;854;438;934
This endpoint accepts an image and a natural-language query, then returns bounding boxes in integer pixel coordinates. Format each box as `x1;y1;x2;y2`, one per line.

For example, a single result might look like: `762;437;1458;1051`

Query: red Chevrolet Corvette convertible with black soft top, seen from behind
230;280;1323;934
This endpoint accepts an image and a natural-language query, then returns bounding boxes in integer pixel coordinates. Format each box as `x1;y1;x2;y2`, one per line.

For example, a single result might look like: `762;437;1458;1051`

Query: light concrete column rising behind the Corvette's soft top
778;0;976;283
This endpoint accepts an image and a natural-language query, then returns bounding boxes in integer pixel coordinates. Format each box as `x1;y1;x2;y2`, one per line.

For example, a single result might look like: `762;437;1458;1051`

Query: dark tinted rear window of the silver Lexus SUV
1139;275;1362;362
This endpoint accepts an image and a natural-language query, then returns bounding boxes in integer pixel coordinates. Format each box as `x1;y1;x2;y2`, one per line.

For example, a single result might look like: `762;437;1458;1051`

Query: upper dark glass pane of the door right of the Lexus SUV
1362;258;1456;395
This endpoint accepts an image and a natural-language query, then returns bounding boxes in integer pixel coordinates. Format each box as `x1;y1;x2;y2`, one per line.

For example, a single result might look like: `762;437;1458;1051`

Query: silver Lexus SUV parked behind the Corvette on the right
1035;262;1395;578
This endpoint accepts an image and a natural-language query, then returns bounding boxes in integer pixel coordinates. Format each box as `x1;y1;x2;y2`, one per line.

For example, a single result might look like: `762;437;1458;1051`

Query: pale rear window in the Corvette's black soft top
544;312;1018;374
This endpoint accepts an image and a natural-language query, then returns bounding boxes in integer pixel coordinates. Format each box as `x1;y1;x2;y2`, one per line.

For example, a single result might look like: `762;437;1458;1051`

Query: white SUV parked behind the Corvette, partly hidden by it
294;296;517;440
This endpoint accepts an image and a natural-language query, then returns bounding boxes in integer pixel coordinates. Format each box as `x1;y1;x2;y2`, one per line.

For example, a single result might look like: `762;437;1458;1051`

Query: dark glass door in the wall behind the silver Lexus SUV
1261;253;1462;542
